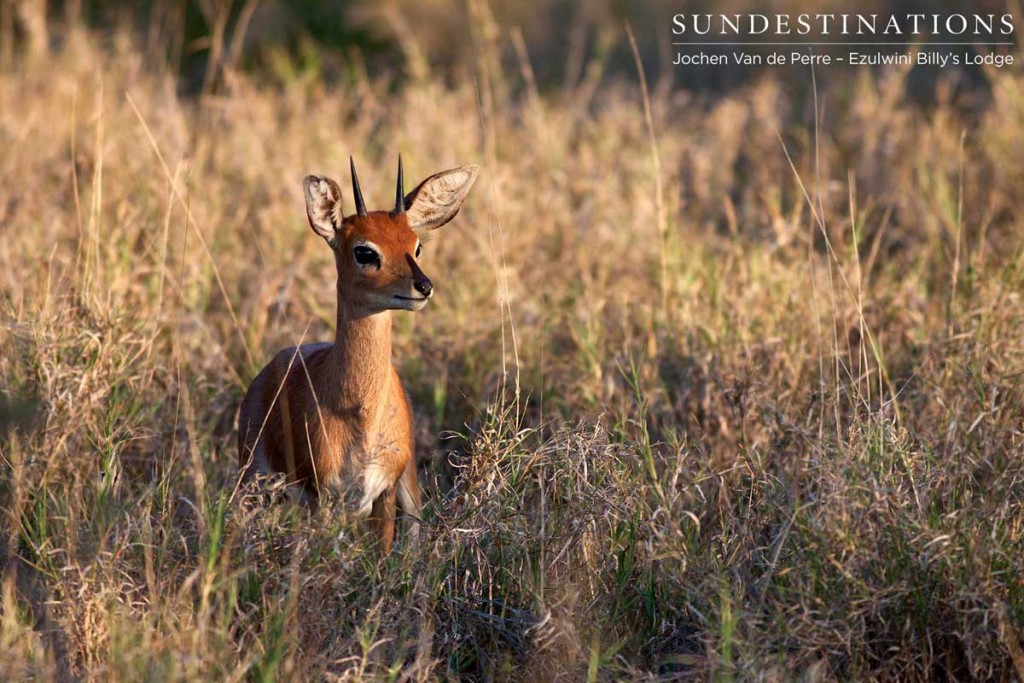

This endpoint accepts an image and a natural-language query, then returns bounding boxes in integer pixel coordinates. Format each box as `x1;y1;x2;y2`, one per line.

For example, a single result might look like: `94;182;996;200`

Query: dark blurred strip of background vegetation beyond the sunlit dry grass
3;0;1021;92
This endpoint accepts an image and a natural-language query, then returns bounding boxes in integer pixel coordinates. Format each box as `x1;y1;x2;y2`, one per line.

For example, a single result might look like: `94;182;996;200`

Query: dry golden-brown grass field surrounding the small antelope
0;1;1024;680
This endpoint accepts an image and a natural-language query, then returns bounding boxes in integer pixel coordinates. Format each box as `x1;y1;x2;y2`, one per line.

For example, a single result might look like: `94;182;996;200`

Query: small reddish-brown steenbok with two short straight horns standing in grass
239;156;479;553
